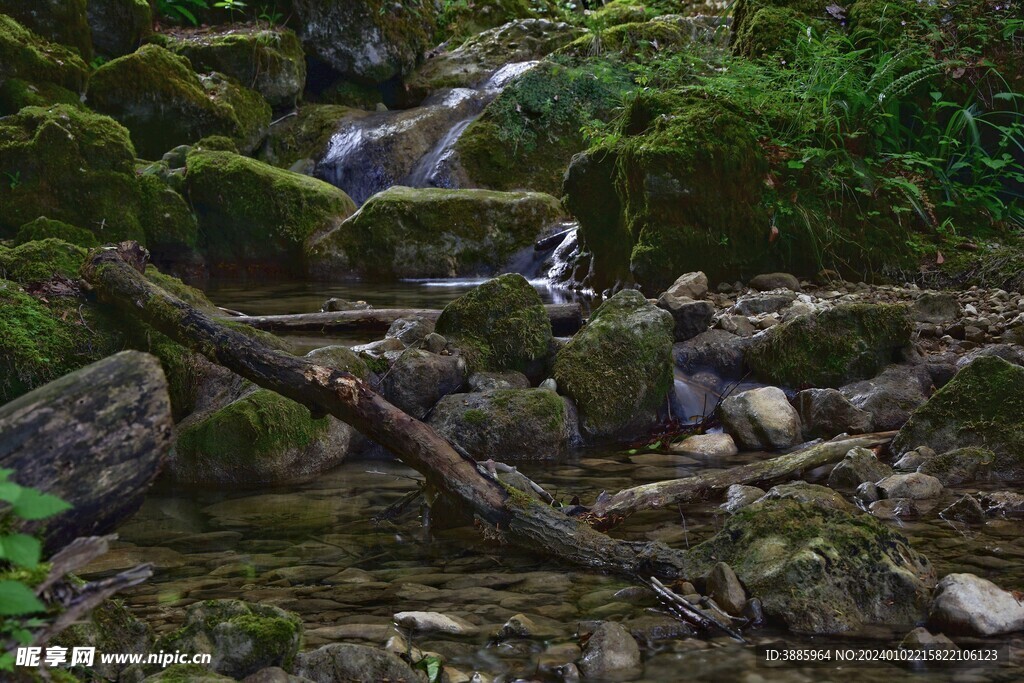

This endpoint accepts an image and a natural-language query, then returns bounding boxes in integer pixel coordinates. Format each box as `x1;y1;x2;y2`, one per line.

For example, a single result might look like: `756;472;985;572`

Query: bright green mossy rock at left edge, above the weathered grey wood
0;276;125;403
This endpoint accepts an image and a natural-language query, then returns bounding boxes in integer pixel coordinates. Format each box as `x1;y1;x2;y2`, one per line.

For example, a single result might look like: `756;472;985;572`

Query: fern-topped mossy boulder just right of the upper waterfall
453;60;630;194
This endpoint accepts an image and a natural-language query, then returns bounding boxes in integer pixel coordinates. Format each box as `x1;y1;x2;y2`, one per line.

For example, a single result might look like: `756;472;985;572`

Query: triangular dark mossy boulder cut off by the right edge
892;355;1024;458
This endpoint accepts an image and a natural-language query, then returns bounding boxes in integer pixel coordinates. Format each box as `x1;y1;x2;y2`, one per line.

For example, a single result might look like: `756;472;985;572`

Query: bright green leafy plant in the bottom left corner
0;469;71;671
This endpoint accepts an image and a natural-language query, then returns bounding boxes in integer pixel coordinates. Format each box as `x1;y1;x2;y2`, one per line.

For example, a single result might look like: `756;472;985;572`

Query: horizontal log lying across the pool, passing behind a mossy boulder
230;303;583;337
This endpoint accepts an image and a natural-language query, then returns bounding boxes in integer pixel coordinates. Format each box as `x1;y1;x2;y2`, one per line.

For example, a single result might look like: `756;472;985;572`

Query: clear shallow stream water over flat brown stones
79;283;1024;683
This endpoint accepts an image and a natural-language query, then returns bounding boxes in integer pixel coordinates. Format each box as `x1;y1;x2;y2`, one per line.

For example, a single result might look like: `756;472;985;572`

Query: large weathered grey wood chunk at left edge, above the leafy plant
0;351;173;552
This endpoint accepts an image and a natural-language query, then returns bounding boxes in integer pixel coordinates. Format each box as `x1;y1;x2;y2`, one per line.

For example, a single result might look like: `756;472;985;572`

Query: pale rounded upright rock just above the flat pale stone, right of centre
719;387;801;451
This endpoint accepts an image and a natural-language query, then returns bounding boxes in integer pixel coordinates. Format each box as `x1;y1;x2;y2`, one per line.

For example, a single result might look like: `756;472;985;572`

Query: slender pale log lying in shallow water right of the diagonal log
586;432;896;528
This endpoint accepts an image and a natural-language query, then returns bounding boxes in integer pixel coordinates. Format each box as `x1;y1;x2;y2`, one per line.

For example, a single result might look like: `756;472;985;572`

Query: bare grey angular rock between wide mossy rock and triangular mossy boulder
840;366;931;430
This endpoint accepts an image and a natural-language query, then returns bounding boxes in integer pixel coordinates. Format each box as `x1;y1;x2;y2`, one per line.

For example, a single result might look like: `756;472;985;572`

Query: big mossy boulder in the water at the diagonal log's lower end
691;499;935;634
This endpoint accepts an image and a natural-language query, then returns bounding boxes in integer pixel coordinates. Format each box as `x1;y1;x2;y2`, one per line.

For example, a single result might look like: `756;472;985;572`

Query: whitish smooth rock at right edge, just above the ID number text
928;573;1024;636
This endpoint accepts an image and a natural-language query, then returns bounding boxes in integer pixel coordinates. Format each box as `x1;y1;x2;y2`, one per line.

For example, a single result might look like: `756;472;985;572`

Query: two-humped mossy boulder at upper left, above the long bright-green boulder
89;45;270;159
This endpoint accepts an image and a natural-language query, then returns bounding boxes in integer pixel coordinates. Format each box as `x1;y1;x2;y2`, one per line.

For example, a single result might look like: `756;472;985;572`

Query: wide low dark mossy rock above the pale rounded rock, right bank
745;304;912;389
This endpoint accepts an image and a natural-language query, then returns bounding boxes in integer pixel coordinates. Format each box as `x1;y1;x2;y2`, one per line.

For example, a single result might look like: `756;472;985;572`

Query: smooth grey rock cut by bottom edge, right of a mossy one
295;643;420;683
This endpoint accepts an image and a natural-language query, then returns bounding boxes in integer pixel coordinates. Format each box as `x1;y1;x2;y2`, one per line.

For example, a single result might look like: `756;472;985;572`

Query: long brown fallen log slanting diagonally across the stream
82;243;694;579
